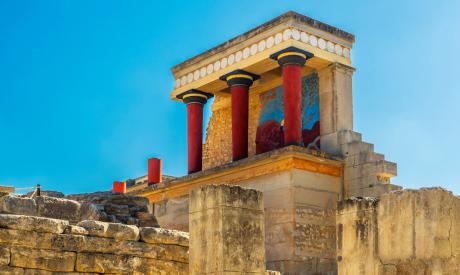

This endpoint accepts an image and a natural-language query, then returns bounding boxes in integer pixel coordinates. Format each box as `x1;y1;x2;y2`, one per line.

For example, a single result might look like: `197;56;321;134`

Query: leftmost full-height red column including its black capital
177;90;212;174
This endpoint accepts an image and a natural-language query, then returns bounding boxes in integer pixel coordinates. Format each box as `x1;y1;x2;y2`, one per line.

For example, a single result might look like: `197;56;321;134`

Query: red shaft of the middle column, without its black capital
230;85;249;160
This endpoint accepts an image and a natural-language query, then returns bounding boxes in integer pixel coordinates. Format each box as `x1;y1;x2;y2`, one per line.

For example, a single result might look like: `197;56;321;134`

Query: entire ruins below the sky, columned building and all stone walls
0;12;460;275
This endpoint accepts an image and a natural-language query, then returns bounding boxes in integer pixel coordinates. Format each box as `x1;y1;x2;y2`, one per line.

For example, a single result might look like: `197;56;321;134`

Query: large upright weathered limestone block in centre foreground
189;185;265;274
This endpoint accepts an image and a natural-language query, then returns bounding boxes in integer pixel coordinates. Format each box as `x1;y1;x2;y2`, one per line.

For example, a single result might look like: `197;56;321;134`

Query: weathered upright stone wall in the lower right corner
337;188;460;275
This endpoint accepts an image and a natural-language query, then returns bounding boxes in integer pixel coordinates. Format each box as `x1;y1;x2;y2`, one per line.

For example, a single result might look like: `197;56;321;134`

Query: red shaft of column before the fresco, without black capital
283;64;302;145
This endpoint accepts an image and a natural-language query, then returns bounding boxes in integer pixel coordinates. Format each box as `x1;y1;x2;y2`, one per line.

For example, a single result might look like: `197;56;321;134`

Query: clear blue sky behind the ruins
0;0;460;194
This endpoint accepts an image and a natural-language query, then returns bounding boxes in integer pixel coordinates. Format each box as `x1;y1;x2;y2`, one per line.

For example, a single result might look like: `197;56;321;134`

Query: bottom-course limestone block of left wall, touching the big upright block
76;253;188;275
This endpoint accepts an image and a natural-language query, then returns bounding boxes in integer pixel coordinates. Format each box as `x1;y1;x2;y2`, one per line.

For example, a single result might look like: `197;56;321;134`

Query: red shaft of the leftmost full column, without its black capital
187;102;203;174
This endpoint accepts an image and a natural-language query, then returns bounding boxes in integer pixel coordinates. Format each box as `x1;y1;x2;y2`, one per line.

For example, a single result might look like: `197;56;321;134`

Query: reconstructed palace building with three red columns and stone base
127;12;400;274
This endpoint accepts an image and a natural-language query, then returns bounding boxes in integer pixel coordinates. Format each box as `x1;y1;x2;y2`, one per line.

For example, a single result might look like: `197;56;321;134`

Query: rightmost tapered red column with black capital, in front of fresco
270;47;313;148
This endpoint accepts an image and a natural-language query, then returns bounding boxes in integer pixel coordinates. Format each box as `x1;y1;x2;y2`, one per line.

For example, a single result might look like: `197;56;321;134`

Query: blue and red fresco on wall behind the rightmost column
256;73;320;154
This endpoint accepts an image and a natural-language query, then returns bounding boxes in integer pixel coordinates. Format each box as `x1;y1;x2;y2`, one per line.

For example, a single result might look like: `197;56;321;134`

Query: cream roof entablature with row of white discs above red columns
171;11;355;99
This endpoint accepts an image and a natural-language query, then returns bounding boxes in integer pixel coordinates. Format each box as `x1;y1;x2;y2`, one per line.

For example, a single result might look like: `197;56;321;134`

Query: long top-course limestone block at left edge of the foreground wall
0;214;69;234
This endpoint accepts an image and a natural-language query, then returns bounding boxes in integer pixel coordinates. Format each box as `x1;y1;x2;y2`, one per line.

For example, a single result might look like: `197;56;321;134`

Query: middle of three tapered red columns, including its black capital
220;70;259;161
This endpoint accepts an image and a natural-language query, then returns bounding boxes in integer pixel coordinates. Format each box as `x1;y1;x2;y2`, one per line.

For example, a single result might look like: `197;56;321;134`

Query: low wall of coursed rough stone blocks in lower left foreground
0;214;188;275
